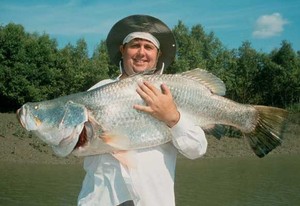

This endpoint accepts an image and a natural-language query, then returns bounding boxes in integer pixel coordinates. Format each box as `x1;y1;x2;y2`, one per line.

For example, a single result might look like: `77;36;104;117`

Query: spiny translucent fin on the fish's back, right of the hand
182;68;226;96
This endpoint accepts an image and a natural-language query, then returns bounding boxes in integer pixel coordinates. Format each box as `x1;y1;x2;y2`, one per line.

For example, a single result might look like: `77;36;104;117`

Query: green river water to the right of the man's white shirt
175;156;300;206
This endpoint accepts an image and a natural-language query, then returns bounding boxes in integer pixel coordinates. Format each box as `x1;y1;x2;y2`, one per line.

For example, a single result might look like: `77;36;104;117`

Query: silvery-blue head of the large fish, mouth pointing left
17;100;88;156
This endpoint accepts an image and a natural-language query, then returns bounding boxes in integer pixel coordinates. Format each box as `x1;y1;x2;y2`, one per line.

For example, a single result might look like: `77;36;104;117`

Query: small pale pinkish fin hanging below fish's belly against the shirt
112;150;137;169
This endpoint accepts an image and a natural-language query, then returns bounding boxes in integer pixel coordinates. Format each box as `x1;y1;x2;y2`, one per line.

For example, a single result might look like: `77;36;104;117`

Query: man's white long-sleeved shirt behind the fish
78;80;207;206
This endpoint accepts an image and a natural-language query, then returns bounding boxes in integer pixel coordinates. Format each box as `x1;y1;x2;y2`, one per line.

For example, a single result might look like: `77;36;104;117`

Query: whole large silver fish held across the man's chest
17;69;288;157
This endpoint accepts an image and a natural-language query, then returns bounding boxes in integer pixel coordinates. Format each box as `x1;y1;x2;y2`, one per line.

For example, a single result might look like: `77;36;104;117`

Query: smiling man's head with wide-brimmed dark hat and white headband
106;15;176;75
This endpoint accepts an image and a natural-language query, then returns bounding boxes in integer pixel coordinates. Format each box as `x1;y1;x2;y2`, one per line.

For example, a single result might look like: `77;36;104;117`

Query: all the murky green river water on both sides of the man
0;156;300;206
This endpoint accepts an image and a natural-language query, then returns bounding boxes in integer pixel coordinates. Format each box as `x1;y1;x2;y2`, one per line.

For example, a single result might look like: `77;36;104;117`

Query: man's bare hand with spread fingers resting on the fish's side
133;81;180;128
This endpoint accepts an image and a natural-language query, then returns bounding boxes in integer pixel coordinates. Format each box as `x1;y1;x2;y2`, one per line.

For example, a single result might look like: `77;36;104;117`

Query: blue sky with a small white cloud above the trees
0;0;300;54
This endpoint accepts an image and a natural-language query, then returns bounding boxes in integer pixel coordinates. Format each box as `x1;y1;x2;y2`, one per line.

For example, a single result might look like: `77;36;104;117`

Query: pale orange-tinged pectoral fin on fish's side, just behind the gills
100;132;130;150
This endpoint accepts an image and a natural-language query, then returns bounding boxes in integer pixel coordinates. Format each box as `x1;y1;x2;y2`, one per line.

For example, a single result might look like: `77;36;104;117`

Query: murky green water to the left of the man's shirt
0;163;84;206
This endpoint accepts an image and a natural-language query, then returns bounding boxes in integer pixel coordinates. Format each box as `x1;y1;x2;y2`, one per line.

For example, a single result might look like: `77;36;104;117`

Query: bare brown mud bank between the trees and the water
0;112;300;164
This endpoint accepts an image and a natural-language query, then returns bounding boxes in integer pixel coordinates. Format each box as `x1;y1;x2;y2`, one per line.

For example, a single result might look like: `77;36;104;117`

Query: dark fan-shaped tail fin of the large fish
246;106;288;157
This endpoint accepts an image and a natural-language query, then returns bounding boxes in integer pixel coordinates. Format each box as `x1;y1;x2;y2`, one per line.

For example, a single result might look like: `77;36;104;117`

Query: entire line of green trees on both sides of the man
0;21;300;112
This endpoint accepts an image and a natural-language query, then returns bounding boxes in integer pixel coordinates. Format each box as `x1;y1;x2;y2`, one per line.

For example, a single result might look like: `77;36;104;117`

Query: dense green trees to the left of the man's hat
0;23;109;111
